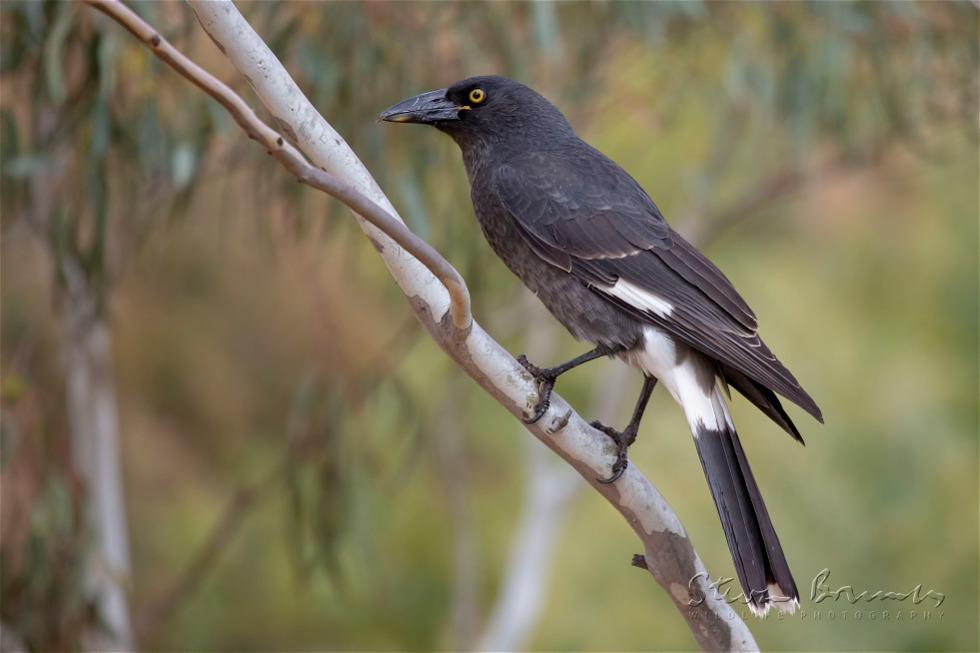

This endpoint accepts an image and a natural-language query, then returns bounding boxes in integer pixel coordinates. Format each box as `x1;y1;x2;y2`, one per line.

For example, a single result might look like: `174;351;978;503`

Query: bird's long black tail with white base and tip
689;386;799;616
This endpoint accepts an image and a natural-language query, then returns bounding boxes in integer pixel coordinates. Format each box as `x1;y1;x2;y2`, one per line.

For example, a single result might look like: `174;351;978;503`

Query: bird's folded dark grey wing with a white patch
492;148;822;420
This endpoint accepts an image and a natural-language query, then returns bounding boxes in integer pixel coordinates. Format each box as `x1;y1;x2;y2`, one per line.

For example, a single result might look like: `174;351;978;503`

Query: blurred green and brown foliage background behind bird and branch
0;1;980;651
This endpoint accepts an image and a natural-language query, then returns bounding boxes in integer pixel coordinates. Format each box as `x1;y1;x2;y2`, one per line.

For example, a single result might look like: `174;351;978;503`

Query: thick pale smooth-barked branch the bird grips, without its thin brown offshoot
189;0;758;650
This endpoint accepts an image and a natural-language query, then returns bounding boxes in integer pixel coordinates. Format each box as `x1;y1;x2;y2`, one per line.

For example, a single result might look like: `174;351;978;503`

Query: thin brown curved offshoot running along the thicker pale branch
84;0;472;329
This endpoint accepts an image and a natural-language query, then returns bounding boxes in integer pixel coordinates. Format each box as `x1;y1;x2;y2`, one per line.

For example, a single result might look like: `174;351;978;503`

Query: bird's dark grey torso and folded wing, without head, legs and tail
467;135;821;422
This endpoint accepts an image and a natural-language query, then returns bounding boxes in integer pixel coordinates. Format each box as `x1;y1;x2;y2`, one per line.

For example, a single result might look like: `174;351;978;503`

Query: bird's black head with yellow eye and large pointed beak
380;76;572;147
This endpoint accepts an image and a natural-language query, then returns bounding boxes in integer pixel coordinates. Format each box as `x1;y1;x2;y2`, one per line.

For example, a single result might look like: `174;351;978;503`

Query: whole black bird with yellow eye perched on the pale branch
381;77;823;614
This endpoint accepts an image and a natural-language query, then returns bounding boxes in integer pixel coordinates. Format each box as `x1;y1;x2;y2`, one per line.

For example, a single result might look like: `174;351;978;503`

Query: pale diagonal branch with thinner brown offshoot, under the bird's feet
86;0;758;650
